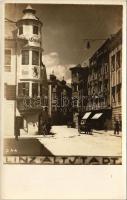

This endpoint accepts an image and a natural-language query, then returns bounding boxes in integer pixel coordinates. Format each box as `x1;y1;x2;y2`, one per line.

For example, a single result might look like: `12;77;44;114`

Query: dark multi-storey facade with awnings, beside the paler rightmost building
86;39;112;129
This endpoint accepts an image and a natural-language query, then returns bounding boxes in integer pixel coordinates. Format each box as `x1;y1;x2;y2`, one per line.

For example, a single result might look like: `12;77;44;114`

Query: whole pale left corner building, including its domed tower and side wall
4;6;48;135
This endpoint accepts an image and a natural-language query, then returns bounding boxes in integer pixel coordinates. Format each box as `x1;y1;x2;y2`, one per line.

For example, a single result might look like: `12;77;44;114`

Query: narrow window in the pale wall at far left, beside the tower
5;49;11;72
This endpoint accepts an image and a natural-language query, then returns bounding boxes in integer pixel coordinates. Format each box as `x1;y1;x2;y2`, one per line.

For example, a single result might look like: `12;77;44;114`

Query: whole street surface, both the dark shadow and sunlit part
4;126;122;156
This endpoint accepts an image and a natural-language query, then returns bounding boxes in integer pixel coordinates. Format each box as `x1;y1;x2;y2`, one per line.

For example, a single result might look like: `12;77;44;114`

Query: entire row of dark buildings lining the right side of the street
70;30;122;130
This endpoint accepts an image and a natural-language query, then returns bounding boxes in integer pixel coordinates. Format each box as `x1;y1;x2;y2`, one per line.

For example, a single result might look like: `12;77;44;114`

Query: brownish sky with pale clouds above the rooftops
5;4;122;83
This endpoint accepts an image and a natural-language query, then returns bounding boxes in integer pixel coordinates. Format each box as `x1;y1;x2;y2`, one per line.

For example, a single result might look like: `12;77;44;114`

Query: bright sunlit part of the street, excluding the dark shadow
38;126;122;156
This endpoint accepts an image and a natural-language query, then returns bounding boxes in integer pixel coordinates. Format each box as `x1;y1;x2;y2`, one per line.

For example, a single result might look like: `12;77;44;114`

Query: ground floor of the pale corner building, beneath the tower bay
4;99;48;136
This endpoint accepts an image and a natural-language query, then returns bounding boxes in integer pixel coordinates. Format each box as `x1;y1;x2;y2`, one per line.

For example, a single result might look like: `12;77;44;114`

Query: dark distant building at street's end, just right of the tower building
48;74;72;125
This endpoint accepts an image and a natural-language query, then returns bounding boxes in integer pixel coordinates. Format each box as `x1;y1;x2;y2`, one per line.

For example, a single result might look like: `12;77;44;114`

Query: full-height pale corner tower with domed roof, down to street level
16;5;48;134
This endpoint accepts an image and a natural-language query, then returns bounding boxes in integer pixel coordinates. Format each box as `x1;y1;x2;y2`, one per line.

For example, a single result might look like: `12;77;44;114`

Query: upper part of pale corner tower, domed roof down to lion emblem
17;5;42;86
